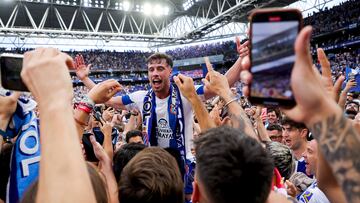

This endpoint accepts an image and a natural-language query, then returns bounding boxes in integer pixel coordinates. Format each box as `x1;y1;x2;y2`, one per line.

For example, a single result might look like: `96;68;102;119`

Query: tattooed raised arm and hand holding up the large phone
242;26;360;202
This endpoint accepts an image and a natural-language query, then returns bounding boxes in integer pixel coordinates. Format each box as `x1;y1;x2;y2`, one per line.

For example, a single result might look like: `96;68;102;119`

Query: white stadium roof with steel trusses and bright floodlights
0;0;344;46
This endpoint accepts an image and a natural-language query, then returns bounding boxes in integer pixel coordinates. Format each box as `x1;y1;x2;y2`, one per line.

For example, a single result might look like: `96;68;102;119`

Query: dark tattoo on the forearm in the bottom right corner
310;115;360;202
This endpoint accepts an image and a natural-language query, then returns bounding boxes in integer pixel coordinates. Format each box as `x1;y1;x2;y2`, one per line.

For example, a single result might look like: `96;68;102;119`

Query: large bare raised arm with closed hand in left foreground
21;48;96;203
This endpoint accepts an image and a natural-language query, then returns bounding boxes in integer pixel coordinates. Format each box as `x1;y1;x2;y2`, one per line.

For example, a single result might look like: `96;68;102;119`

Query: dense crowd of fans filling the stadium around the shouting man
0;0;360;203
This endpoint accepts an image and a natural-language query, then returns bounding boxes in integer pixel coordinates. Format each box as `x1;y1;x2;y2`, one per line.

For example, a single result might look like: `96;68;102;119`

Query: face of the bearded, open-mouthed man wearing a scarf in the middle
148;59;171;93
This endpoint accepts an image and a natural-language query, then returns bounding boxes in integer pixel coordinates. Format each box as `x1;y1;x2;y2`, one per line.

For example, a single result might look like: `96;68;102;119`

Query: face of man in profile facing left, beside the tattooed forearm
303;140;318;175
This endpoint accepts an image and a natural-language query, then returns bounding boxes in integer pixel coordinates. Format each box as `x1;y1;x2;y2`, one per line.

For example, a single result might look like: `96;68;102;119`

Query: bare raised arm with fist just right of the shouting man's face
174;74;216;131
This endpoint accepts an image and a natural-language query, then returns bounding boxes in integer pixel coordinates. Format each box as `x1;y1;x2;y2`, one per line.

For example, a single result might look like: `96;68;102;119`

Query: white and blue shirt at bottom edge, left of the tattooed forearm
298;180;330;203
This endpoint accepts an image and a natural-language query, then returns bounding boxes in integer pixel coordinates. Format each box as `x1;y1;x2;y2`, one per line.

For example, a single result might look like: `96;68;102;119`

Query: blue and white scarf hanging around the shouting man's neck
142;85;186;162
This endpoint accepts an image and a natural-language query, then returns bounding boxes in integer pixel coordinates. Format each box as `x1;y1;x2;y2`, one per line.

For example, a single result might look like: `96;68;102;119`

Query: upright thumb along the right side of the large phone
295;26;312;68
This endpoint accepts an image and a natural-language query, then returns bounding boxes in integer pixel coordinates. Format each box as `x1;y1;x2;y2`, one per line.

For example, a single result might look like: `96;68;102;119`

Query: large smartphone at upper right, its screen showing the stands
249;8;303;108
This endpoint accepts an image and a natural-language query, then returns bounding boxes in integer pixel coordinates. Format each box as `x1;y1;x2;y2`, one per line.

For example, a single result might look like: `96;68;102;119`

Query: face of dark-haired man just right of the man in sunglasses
282;125;302;150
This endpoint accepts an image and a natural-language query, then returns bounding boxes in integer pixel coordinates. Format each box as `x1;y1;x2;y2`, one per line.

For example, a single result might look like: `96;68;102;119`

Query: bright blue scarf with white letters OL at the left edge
6;99;40;203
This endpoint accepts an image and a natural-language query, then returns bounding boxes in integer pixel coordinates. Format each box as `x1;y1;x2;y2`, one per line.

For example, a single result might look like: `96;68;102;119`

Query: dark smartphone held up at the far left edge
0;53;29;92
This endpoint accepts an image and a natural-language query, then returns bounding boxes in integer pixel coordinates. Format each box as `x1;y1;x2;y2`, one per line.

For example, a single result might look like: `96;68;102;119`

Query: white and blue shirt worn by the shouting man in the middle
122;86;203;160
